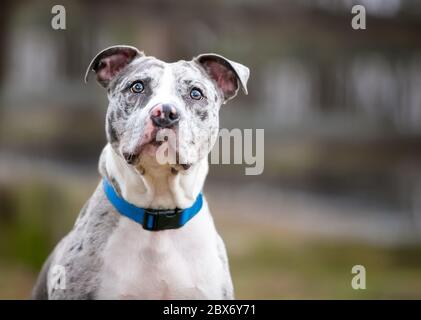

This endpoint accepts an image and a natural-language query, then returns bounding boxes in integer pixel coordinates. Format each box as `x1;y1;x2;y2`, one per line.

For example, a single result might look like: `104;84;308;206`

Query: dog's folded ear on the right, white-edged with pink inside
193;53;250;102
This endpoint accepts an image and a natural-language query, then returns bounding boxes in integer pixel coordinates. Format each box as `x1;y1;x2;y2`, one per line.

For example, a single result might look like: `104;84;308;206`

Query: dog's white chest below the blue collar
97;215;223;299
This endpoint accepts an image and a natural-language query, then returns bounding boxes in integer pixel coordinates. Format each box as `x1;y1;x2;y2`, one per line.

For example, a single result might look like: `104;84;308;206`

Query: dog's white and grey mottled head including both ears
86;46;249;169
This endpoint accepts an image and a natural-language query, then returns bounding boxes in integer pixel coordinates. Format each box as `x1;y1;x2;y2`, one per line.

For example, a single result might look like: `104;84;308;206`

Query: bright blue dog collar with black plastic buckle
102;178;203;231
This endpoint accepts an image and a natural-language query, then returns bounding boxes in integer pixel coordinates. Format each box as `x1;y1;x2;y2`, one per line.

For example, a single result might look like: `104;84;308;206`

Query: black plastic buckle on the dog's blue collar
143;208;184;231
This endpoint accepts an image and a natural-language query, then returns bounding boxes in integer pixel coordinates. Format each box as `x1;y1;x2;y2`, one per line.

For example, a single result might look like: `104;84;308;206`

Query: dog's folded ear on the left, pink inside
85;45;144;87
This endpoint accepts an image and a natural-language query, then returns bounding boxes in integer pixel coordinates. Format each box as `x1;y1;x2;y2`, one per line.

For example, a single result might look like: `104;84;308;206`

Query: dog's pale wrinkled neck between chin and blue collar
99;144;208;209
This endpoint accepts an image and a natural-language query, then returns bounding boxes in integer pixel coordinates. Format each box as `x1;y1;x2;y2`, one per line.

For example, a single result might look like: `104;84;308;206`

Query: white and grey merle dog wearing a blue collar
32;45;250;299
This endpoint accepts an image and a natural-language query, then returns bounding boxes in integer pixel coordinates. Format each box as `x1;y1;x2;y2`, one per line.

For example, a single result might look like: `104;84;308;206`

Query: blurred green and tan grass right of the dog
218;219;421;299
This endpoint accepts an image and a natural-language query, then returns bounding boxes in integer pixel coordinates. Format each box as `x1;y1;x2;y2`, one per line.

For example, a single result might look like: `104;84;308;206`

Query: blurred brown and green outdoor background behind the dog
0;0;421;299
